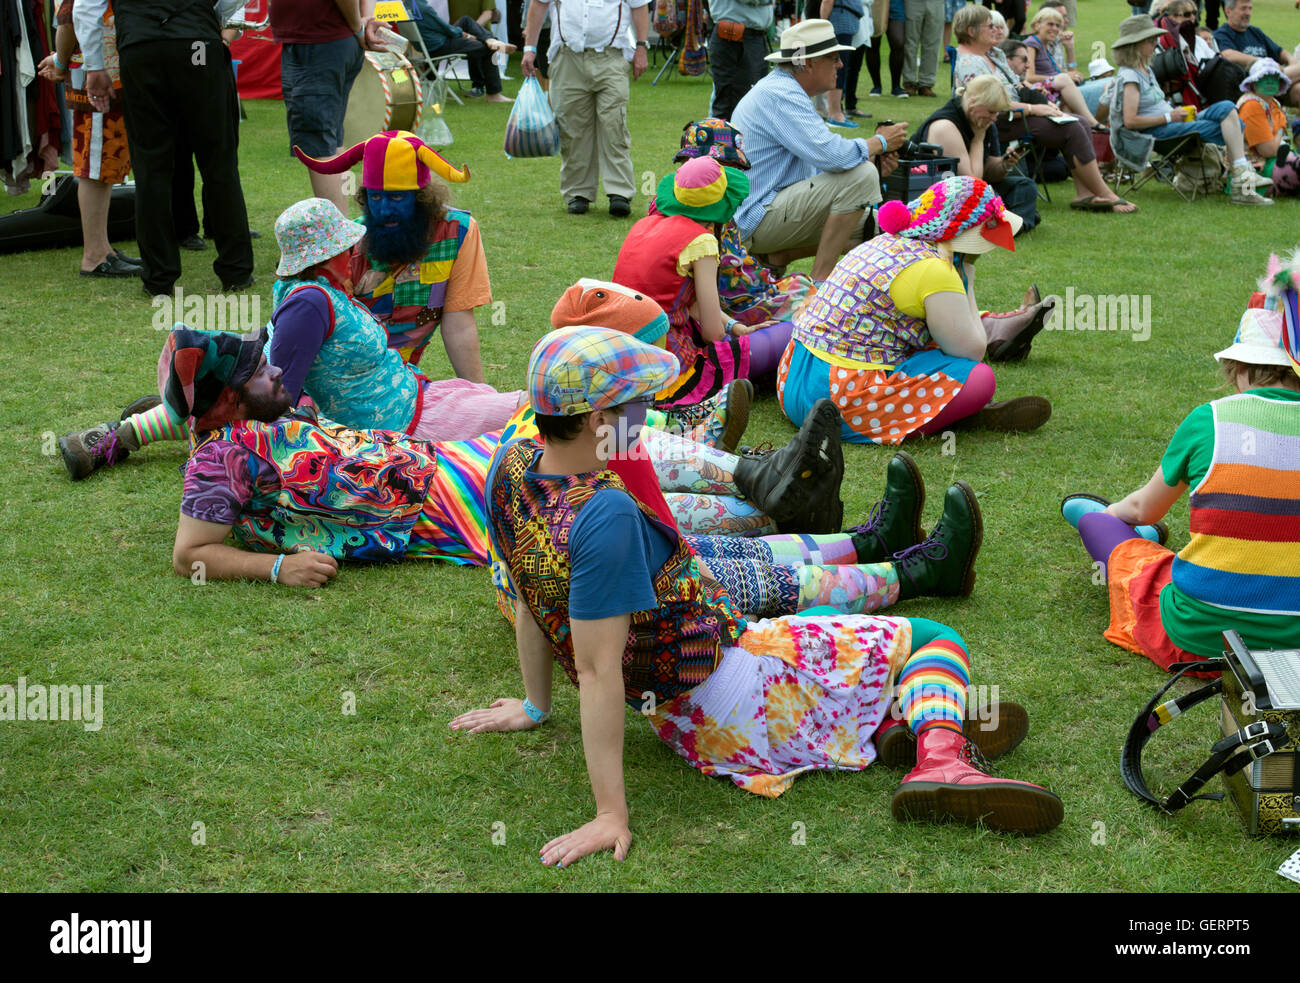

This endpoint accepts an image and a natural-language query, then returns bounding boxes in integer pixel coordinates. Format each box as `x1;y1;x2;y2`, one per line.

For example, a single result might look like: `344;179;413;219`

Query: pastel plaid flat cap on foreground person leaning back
528;325;679;416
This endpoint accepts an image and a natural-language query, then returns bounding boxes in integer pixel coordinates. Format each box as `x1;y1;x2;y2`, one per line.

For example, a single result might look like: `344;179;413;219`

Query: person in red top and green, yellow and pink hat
614;157;790;404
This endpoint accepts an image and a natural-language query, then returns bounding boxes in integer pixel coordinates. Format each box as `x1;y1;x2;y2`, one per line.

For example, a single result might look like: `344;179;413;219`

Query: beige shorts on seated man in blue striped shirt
745;160;880;254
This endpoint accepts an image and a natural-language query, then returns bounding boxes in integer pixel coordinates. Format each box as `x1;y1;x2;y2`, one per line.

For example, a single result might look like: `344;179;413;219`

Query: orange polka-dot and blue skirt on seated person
776;341;976;443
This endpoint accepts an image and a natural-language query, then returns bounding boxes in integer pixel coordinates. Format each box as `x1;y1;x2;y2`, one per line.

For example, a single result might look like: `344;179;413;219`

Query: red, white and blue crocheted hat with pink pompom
876;177;1024;252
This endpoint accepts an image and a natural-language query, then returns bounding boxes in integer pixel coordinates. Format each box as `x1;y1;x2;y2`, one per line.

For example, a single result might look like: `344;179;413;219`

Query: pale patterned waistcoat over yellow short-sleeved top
794;235;940;365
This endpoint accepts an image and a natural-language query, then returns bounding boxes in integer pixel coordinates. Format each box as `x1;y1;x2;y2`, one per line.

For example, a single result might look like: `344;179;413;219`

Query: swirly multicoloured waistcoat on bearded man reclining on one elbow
194;411;438;560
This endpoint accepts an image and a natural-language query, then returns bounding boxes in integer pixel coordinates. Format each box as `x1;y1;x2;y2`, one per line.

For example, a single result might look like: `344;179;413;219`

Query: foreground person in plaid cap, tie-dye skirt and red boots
450;328;1063;867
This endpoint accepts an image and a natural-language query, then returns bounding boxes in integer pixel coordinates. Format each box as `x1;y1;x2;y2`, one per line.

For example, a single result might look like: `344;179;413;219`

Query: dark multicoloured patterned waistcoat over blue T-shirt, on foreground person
488;438;744;706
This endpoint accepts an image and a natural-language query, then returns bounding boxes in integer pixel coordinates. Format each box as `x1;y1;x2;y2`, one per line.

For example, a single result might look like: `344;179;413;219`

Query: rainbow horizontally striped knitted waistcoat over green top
1173;393;1300;615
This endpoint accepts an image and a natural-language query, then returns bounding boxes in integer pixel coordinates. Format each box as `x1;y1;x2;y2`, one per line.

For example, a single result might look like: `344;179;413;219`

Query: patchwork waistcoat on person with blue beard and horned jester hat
356;208;471;365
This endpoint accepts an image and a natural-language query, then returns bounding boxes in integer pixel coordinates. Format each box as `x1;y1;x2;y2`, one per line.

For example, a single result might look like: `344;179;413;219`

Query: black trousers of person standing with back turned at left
120;40;252;294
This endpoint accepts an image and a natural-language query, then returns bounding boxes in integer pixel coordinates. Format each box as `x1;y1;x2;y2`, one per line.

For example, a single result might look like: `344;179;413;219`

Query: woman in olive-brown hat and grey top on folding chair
1110;16;1273;205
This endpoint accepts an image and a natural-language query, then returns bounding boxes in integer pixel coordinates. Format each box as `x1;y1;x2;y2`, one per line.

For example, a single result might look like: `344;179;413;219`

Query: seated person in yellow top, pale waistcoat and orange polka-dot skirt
777;176;1054;443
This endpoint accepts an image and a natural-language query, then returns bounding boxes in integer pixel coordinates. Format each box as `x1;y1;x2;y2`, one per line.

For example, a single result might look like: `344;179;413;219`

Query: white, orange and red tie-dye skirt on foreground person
650;615;911;798
